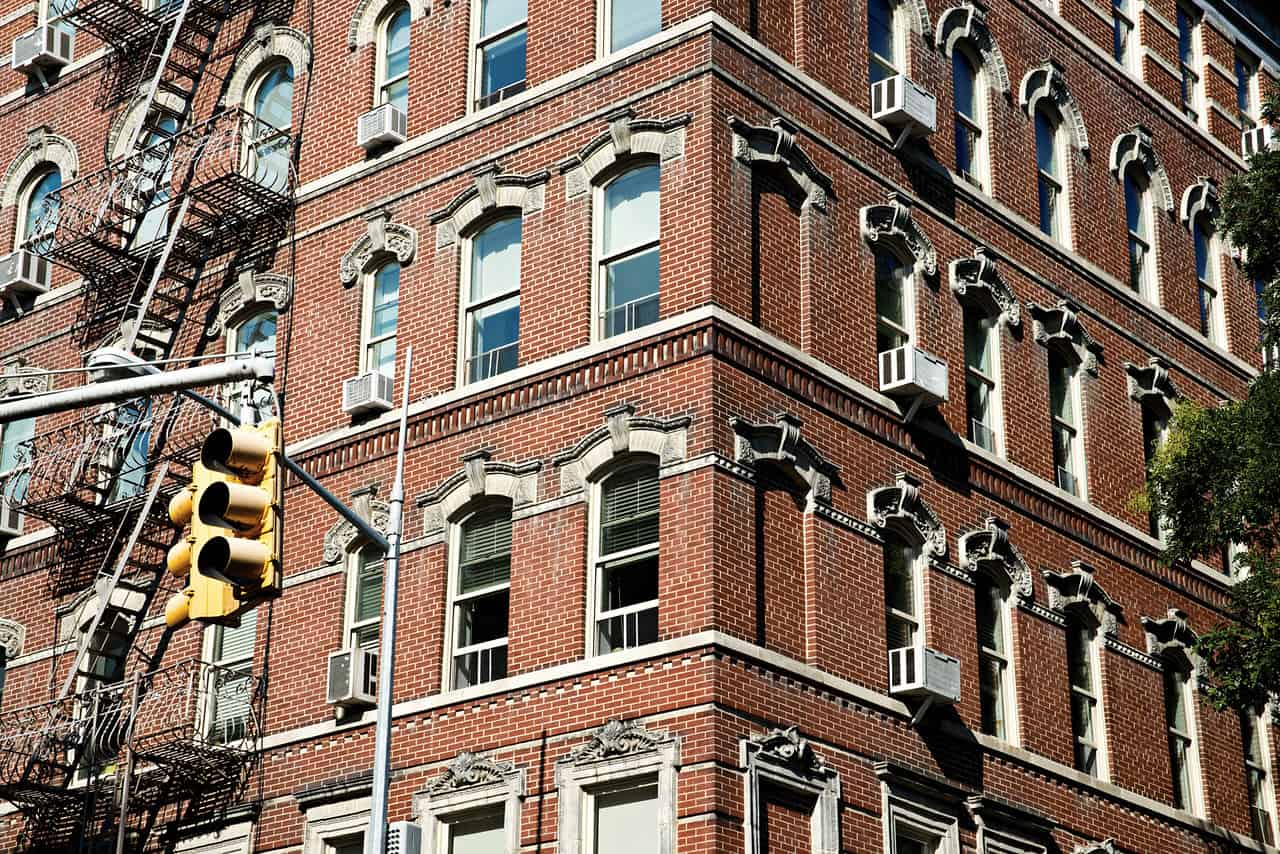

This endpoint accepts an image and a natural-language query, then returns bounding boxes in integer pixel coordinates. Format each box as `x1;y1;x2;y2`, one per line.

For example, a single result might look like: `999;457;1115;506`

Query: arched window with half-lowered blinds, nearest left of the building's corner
594;462;659;654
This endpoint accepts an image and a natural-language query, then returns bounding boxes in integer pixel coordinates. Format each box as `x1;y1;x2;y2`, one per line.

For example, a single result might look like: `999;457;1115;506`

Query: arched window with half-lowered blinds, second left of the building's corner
451;506;511;688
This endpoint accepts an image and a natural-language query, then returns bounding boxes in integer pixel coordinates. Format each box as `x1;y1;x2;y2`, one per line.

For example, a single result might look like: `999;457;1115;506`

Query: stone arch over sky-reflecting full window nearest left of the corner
559;109;692;198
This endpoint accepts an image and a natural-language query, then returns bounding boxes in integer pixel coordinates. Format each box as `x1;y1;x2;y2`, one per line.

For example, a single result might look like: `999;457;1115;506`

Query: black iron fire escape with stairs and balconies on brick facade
0;0;296;854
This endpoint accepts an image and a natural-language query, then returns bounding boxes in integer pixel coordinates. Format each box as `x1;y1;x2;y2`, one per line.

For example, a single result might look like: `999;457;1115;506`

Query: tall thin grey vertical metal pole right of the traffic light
365;347;413;854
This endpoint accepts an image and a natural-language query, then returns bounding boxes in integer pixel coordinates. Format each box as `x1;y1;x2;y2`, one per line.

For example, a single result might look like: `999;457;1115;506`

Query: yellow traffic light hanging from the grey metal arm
165;419;284;627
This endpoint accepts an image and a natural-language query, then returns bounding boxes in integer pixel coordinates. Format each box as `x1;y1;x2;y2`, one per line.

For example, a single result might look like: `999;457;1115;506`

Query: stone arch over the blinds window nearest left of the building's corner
553;403;692;495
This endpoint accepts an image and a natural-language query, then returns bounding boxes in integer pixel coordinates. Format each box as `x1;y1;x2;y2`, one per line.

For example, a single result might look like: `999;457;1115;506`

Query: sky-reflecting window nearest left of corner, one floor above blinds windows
596;164;660;338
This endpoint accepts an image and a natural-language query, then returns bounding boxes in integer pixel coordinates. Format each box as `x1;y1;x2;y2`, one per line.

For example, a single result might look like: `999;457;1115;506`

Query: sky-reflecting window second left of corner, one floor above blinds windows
462;216;521;383
